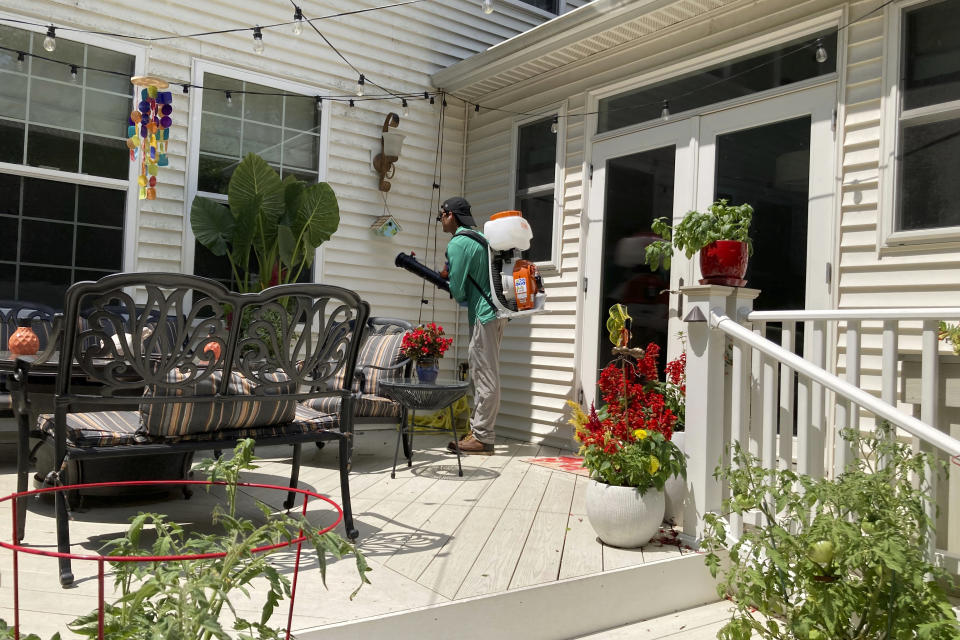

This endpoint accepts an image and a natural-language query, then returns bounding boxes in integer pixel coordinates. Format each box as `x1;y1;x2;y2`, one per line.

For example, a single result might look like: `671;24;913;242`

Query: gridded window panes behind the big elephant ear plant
193;73;321;286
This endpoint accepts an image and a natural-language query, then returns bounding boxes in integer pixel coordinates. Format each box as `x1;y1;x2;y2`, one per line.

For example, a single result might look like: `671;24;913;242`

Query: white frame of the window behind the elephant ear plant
181;58;333;281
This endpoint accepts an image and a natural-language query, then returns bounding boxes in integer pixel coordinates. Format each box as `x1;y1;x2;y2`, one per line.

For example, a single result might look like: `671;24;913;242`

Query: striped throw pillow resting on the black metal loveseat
140;369;297;439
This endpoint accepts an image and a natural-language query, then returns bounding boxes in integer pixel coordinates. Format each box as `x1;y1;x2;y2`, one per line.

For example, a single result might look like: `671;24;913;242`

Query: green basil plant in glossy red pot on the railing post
646;199;753;287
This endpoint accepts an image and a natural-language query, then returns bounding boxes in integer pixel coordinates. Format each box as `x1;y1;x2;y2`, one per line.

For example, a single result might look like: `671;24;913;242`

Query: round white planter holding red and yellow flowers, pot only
586;480;664;549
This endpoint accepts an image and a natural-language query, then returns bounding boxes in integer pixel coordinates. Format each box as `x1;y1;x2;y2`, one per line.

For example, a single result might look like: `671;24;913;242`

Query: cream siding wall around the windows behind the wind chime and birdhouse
0;0;560;376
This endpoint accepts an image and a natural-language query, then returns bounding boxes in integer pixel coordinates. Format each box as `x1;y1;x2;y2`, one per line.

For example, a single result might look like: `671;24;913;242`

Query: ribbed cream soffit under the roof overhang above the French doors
433;0;740;100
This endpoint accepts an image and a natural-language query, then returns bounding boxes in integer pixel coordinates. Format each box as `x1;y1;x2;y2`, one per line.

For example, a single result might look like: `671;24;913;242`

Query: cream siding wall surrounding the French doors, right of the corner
454;0;960;440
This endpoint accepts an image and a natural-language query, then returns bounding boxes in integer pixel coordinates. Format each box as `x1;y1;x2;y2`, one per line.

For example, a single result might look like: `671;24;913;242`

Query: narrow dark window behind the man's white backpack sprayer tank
514;115;557;262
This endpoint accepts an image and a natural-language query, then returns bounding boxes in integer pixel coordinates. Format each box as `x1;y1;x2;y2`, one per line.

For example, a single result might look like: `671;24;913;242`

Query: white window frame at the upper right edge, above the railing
877;0;960;249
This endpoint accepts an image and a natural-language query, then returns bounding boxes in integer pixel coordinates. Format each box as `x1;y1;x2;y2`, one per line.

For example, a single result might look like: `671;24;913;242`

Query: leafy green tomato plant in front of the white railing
702;424;960;640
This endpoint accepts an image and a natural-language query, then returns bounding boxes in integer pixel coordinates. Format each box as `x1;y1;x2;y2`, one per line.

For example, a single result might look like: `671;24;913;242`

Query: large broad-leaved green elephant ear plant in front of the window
190;153;340;292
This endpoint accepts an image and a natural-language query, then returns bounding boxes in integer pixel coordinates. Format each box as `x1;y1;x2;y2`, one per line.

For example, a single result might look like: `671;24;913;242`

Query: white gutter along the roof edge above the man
431;0;673;91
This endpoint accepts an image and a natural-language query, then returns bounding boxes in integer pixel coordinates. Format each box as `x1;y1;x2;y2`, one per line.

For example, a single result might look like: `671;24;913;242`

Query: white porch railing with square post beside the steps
682;286;960;564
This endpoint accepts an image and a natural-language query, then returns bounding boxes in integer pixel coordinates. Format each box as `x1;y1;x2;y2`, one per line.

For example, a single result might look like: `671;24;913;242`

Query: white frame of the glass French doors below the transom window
577;81;837;403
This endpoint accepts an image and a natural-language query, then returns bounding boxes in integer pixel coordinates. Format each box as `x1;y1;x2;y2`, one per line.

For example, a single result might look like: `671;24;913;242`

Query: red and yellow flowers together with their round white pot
569;305;686;548
